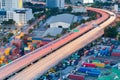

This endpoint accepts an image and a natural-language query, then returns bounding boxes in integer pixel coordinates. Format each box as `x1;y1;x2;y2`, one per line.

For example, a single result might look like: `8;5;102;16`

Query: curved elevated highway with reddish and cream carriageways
0;8;116;80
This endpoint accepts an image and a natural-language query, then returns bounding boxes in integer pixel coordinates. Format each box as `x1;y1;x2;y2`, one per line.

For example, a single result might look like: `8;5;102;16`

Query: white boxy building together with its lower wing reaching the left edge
0;8;33;25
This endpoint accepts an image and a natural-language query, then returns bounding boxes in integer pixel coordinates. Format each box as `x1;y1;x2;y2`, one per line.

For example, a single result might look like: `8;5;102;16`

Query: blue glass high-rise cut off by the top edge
46;0;65;9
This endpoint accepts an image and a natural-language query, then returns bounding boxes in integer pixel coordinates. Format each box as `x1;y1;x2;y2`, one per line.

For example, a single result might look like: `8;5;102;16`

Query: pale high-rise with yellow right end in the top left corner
0;0;23;10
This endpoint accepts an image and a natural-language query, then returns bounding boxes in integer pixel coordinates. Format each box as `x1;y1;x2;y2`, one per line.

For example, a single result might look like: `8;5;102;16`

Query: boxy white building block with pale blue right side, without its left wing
13;8;33;25
